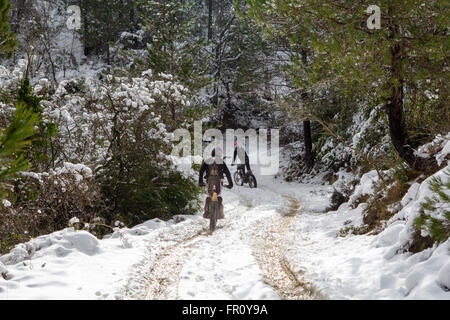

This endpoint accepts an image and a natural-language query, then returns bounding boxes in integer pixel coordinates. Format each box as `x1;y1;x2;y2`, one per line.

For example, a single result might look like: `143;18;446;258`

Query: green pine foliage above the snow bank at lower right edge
414;169;450;243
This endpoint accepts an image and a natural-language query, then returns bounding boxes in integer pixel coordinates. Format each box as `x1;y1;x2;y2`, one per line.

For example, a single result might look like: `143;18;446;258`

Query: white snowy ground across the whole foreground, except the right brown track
0;156;450;299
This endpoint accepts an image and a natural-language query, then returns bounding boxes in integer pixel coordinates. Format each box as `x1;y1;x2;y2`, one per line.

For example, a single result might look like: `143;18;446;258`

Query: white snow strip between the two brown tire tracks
165;197;279;300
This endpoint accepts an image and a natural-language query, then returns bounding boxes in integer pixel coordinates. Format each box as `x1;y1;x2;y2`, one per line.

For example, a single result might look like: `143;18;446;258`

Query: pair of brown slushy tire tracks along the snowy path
145;190;314;300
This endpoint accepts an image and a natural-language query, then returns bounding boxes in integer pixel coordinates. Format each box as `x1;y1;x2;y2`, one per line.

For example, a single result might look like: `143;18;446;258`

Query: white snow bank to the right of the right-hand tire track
286;167;450;299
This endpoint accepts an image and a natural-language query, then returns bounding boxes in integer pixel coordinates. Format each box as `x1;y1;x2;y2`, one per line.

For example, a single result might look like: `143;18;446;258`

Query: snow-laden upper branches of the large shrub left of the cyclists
45;71;189;164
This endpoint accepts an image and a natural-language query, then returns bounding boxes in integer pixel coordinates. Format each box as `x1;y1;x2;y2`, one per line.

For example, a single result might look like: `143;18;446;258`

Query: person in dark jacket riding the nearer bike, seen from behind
198;148;233;219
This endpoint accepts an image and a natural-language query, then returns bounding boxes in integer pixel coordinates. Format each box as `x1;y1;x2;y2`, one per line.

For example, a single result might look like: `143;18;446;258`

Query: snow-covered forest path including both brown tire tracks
139;172;328;300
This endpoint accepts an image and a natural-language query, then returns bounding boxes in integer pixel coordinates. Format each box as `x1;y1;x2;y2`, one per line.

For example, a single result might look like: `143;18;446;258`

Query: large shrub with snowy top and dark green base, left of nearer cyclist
46;70;199;225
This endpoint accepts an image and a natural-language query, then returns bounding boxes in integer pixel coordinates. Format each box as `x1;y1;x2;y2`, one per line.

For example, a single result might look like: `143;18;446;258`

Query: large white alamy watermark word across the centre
172;121;280;175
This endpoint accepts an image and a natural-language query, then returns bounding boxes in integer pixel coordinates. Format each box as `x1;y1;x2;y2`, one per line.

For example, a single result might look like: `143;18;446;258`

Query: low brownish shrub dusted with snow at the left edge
0;163;100;252
